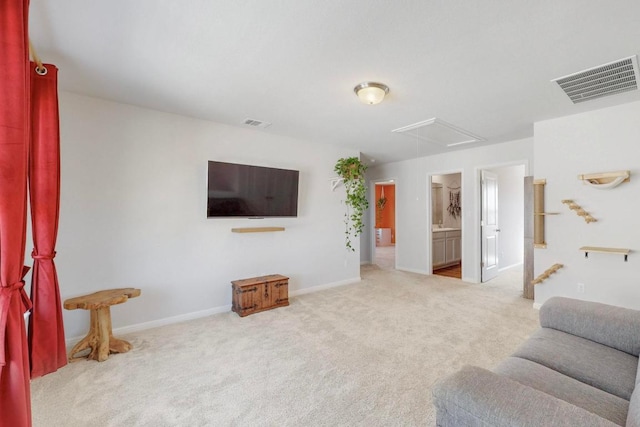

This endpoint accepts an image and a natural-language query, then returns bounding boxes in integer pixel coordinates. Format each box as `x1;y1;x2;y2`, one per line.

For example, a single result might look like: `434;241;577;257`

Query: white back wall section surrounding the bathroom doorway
363;138;533;282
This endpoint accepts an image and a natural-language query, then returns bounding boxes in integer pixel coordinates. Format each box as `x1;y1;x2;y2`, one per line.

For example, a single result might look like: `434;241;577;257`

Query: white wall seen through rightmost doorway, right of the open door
491;165;524;269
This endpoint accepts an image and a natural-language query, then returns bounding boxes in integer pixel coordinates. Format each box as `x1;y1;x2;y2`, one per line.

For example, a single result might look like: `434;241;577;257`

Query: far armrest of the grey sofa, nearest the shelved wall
540;297;640;357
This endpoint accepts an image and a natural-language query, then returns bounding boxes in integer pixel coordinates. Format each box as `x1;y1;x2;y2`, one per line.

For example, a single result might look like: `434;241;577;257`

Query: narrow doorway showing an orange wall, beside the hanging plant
372;180;396;270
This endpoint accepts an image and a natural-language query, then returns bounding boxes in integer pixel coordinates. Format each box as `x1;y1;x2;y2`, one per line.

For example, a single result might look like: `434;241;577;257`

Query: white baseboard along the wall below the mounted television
65;276;362;347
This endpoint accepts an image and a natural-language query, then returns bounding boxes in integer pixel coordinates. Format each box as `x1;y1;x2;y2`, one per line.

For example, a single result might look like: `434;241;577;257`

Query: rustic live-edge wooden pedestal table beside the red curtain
64;288;140;362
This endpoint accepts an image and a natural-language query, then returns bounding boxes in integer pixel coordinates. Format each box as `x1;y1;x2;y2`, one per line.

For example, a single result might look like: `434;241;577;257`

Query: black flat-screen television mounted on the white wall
207;161;299;218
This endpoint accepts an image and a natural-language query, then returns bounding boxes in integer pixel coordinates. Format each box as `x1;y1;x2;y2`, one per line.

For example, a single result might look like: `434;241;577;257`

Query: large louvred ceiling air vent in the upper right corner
552;55;639;104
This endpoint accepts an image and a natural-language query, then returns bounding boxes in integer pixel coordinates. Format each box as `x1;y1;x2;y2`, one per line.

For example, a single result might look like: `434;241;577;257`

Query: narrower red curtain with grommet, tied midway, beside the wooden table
29;62;67;378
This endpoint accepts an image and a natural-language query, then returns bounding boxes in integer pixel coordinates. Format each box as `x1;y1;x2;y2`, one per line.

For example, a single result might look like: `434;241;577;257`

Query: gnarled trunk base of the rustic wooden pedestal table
69;307;132;362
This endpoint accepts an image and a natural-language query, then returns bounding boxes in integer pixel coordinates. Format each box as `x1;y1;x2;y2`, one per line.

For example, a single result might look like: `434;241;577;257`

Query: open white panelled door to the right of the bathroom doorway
480;171;500;282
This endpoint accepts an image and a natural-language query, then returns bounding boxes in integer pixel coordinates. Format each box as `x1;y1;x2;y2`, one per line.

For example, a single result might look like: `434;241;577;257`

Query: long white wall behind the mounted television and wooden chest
56;92;360;337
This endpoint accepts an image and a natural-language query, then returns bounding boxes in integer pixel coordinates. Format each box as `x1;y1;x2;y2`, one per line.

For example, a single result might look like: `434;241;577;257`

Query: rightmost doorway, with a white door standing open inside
480;164;526;283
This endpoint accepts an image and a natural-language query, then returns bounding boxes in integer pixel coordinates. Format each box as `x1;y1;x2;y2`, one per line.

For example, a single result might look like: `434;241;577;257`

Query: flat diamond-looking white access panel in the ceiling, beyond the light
391;117;485;147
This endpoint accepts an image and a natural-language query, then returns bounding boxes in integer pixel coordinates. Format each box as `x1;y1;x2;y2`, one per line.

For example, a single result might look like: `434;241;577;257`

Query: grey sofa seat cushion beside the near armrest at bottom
493;357;629;426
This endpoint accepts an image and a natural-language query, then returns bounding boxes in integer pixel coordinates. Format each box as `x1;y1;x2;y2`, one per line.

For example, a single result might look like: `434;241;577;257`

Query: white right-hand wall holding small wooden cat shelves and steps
534;102;640;309
